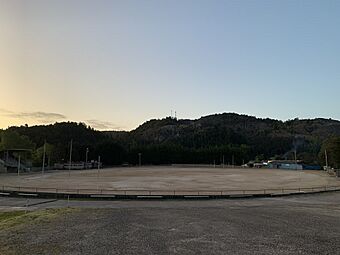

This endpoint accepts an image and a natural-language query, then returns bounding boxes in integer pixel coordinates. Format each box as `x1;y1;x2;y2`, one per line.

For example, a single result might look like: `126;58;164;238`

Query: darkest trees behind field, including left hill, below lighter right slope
0;118;340;167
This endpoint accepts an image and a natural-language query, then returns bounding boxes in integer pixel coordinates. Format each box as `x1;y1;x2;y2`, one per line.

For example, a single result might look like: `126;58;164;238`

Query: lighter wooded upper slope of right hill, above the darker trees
126;113;340;147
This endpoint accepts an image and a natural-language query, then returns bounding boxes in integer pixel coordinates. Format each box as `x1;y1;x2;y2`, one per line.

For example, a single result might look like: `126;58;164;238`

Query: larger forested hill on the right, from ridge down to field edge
108;113;340;164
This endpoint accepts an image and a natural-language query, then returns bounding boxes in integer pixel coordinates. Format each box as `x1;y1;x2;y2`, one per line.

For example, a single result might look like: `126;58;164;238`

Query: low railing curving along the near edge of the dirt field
0;185;340;199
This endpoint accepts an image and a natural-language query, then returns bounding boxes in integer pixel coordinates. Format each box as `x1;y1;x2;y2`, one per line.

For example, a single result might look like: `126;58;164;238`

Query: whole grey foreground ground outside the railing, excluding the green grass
0;193;340;254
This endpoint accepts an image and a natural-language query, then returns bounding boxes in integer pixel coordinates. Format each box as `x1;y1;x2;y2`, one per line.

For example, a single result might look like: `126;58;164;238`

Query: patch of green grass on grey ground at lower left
0;208;76;231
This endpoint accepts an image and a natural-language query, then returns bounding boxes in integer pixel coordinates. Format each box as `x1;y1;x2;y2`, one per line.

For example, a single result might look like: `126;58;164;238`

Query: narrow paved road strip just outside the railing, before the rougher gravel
0;192;340;211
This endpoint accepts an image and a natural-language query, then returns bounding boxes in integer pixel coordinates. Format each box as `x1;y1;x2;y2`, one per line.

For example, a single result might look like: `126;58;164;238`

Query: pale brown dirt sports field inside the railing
0;166;340;190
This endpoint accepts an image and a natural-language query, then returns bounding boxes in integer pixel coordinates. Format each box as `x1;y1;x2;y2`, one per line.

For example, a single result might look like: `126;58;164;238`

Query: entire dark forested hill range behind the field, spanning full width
0;113;340;167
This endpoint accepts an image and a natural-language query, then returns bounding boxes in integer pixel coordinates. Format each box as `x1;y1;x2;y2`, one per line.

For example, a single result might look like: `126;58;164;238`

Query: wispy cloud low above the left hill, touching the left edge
0;109;66;123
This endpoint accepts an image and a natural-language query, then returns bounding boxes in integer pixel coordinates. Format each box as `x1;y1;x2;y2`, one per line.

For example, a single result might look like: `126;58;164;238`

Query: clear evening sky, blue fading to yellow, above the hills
0;0;340;130
